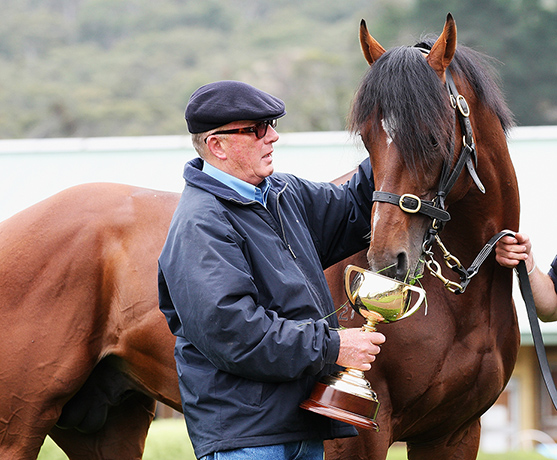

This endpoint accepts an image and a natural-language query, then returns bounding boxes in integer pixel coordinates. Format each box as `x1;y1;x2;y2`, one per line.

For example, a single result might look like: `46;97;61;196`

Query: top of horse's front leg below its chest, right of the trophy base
407;419;481;460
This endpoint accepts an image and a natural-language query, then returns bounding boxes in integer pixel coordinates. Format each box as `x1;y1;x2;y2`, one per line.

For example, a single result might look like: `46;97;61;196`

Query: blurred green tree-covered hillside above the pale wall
0;0;557;138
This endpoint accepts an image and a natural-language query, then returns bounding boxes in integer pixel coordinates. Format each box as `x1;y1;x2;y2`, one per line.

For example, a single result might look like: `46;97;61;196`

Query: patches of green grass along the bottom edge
38;419;547;460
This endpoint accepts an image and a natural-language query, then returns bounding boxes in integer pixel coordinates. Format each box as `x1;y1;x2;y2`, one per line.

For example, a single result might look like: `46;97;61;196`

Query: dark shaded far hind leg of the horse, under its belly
49;392;155;460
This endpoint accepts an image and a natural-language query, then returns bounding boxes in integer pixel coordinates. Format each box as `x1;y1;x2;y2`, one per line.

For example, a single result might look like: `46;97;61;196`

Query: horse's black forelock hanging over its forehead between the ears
350;47;454;172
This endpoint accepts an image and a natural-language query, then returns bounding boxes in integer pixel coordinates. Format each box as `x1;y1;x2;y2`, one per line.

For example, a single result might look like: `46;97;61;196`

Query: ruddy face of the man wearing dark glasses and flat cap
207;121;279;185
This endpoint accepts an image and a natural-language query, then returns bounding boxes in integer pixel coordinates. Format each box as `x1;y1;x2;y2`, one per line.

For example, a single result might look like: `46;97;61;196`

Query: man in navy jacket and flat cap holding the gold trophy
159;81;385;460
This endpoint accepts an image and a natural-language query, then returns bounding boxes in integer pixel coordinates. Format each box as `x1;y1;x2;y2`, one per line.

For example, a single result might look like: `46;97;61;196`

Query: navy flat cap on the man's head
186;80;286;134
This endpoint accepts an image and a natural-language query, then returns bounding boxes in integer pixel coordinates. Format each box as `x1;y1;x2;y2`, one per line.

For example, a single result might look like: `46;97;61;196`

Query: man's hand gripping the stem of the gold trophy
336;328;385;371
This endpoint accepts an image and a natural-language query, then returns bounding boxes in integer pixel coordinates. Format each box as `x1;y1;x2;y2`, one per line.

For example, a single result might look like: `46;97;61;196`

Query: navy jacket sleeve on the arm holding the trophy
159;199;340;381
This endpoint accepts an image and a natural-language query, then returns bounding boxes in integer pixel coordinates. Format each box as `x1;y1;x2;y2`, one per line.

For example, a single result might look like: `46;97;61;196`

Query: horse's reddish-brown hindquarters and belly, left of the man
0;184;181;460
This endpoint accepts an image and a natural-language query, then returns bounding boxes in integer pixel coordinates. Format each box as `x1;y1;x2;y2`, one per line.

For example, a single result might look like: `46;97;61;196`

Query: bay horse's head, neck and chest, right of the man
327;15;519;460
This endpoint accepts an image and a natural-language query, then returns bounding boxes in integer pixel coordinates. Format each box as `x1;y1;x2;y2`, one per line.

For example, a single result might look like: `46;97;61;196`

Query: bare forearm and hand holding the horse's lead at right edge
495;233;557;322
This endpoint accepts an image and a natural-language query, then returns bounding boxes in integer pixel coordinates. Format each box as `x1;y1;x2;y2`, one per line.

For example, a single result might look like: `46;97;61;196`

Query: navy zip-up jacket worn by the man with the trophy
159;159;373;457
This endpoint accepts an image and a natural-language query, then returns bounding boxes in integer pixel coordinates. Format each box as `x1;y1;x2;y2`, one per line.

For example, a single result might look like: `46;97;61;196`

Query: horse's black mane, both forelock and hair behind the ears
348;38;514;171
